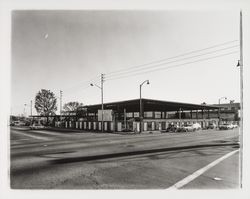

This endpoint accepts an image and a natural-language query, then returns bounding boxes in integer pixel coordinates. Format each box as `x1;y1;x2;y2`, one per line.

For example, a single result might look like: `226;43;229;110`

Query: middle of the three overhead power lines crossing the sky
105;45;239;78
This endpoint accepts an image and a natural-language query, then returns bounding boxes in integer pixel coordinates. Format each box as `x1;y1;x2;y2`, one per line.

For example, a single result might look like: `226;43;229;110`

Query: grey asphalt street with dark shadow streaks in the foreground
10;127;239;189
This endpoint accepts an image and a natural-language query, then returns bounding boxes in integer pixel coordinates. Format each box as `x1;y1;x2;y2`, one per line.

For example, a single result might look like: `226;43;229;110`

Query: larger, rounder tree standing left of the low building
35;89;57;122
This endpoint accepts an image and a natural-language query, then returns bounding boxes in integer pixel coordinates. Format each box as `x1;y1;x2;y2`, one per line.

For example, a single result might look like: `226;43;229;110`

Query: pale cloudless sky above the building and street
11;10;240;115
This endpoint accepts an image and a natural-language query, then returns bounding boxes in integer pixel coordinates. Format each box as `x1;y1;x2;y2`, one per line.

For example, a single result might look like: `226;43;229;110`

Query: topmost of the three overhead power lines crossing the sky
107;40;238;76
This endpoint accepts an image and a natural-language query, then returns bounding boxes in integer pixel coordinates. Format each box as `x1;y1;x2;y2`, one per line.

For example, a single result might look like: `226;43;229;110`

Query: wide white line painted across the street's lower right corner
168;149;239;189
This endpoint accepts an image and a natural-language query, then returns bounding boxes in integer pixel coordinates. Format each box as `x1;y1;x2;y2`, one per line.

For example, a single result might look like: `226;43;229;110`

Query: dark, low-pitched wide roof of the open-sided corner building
79;98;218;112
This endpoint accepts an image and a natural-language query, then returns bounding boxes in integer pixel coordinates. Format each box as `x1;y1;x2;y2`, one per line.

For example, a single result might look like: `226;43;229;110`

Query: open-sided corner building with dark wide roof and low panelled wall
53;99;225;132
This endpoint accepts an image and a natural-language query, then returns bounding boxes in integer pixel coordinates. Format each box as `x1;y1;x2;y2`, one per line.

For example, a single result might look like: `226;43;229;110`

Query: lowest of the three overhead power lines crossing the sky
107;51;239;81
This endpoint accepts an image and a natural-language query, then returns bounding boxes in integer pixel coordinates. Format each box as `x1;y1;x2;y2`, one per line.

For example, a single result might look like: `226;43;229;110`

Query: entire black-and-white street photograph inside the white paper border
0;0;248;197
